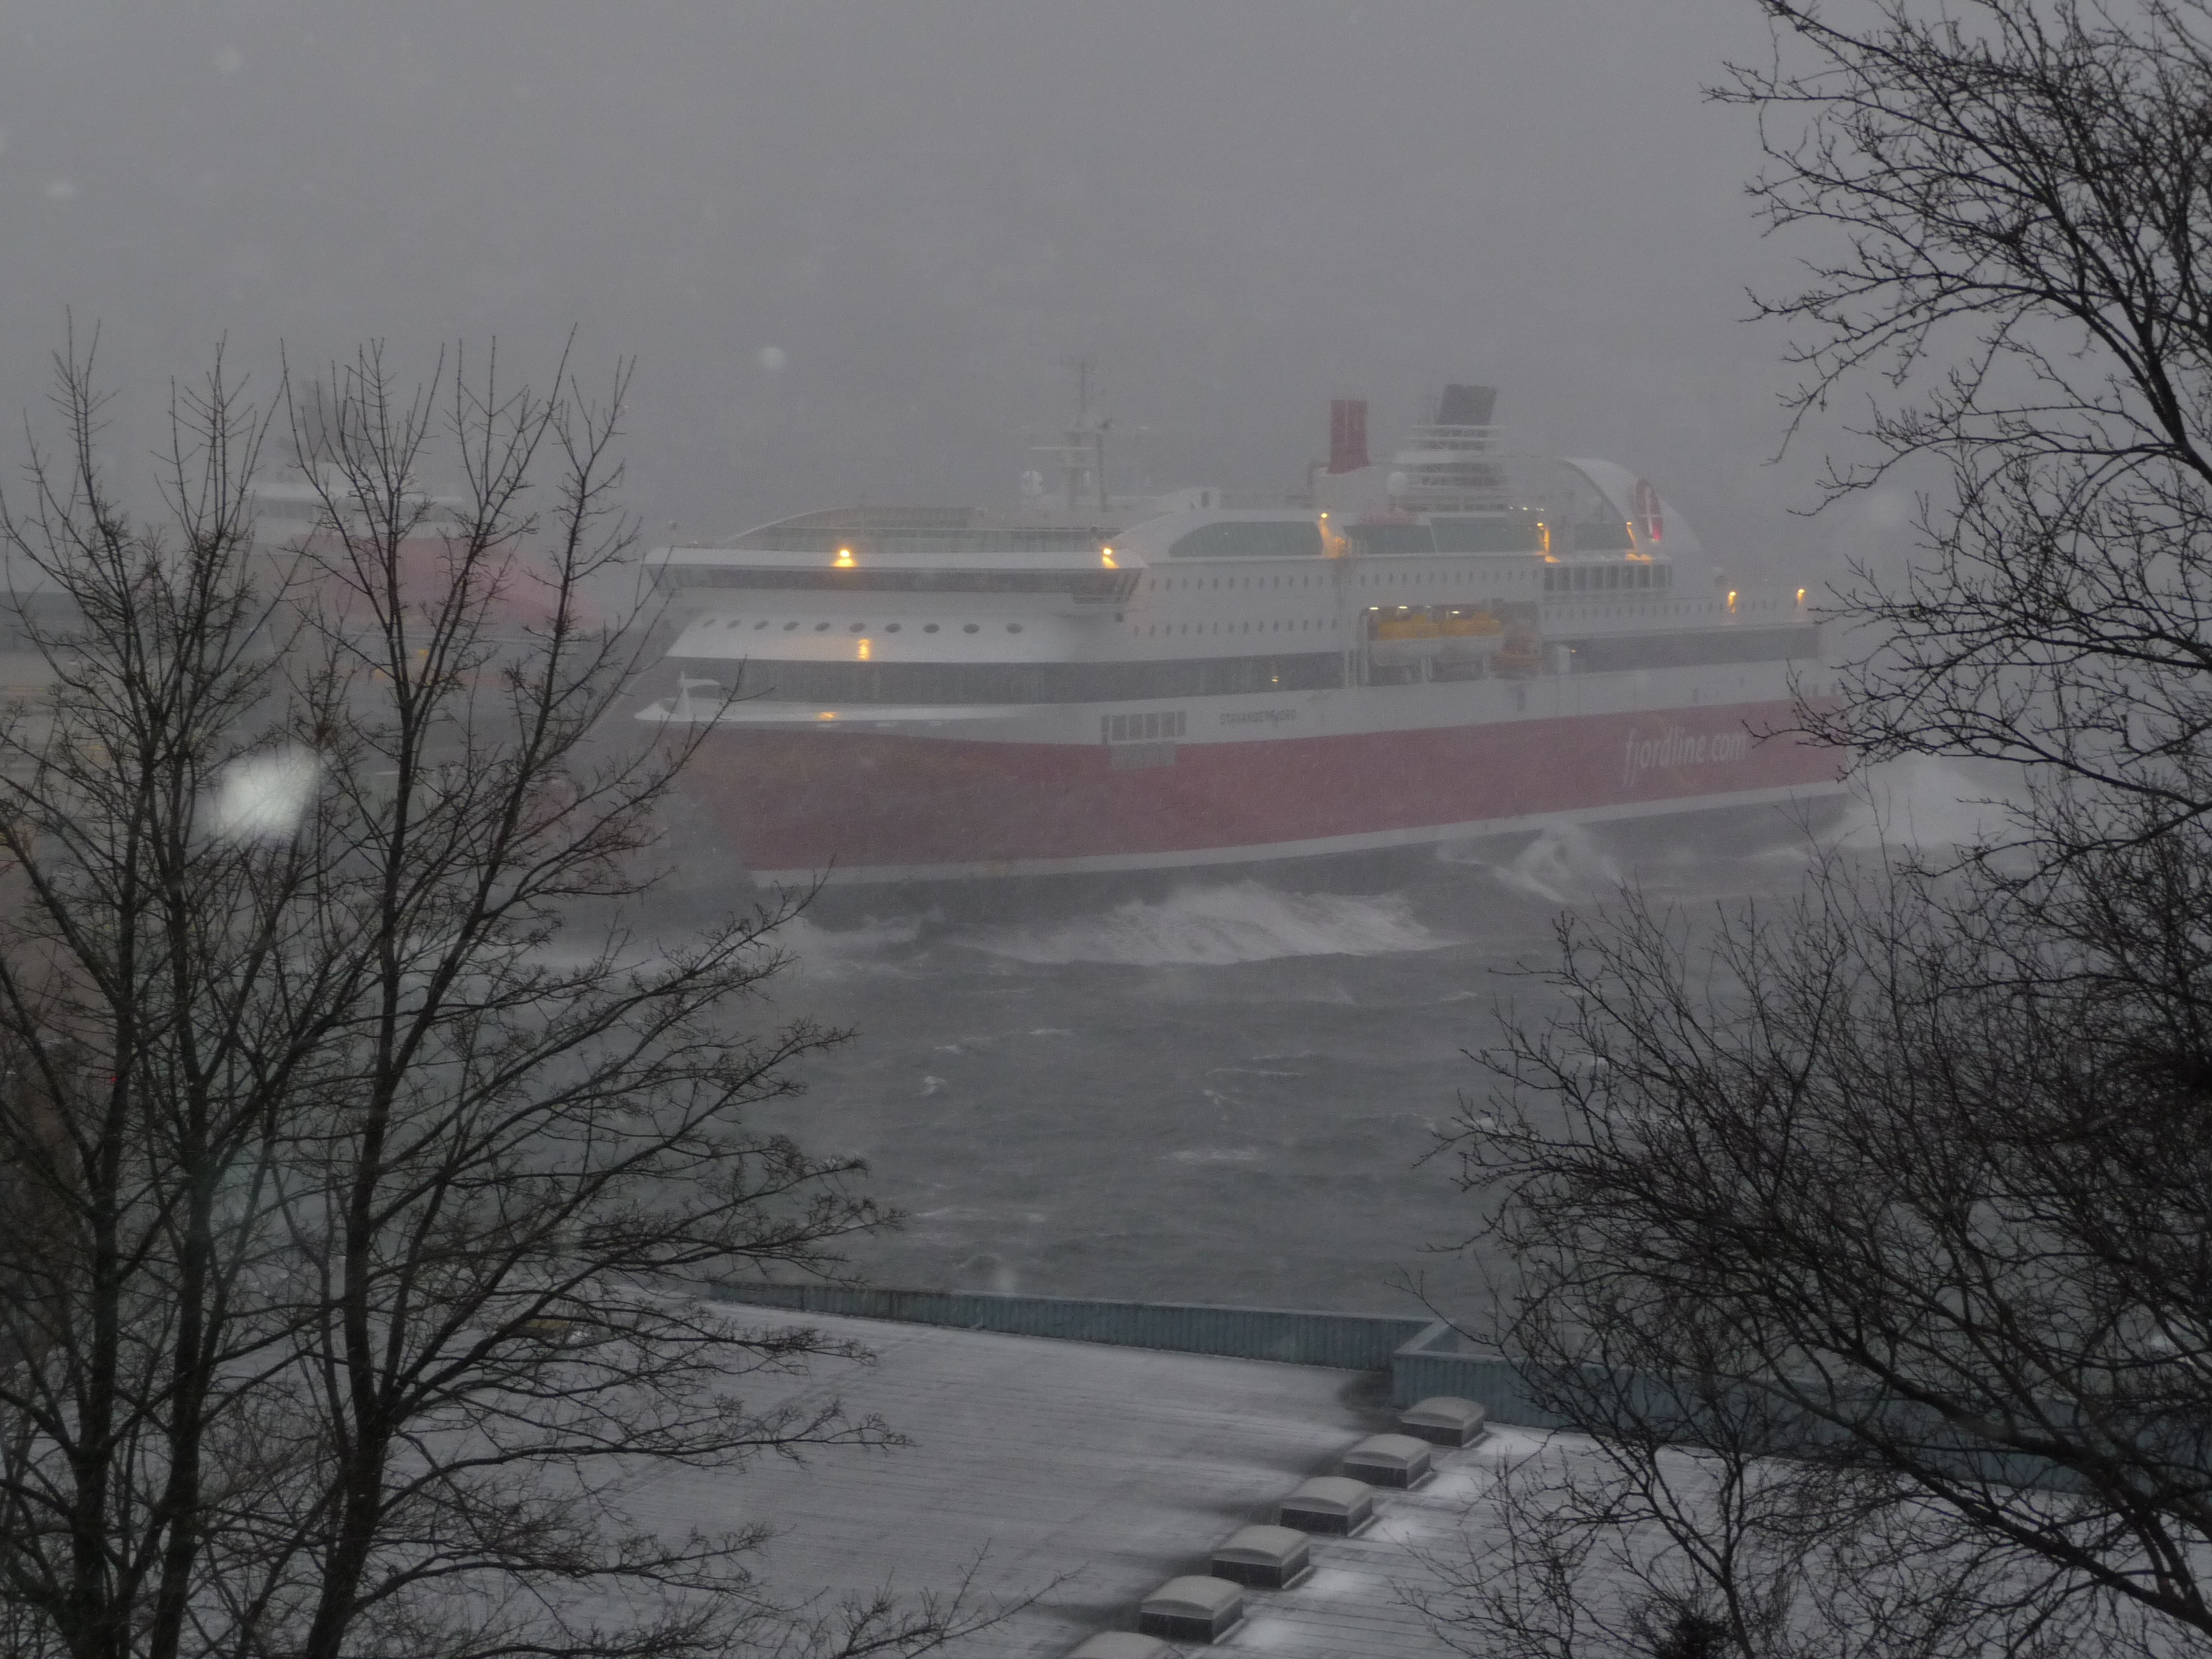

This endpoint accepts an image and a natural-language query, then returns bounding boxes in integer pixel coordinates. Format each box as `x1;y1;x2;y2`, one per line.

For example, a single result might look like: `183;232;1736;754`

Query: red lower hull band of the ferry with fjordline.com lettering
690;703;1838;880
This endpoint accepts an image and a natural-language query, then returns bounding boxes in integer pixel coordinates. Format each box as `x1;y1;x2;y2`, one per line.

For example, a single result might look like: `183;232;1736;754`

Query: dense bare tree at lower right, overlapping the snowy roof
1455;828;2212;1655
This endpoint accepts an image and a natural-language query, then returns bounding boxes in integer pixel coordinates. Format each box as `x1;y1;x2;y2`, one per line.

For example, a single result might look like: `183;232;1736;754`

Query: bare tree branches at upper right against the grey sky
1717;0;2212;847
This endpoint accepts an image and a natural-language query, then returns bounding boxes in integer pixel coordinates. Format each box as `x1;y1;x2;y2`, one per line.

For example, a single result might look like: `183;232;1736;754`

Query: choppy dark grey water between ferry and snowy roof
734;821;1858;1311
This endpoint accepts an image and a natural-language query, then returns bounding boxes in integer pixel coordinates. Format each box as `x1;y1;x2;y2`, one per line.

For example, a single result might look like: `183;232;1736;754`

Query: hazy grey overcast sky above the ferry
0;0;1893;564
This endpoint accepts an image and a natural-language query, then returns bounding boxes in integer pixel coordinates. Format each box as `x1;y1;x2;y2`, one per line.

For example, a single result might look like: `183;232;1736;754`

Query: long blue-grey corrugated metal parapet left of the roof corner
717;1285;1433;1391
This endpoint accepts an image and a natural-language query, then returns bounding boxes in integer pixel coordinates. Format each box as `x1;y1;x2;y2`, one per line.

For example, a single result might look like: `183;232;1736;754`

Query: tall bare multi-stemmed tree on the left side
0;333;995;1659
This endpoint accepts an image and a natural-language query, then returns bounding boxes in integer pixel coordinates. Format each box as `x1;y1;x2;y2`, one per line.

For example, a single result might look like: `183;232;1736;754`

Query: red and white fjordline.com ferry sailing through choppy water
639;385;1840;885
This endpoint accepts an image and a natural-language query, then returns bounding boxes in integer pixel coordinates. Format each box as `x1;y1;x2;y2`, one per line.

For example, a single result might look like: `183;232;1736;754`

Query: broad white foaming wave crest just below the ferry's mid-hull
965;880;1455;966
